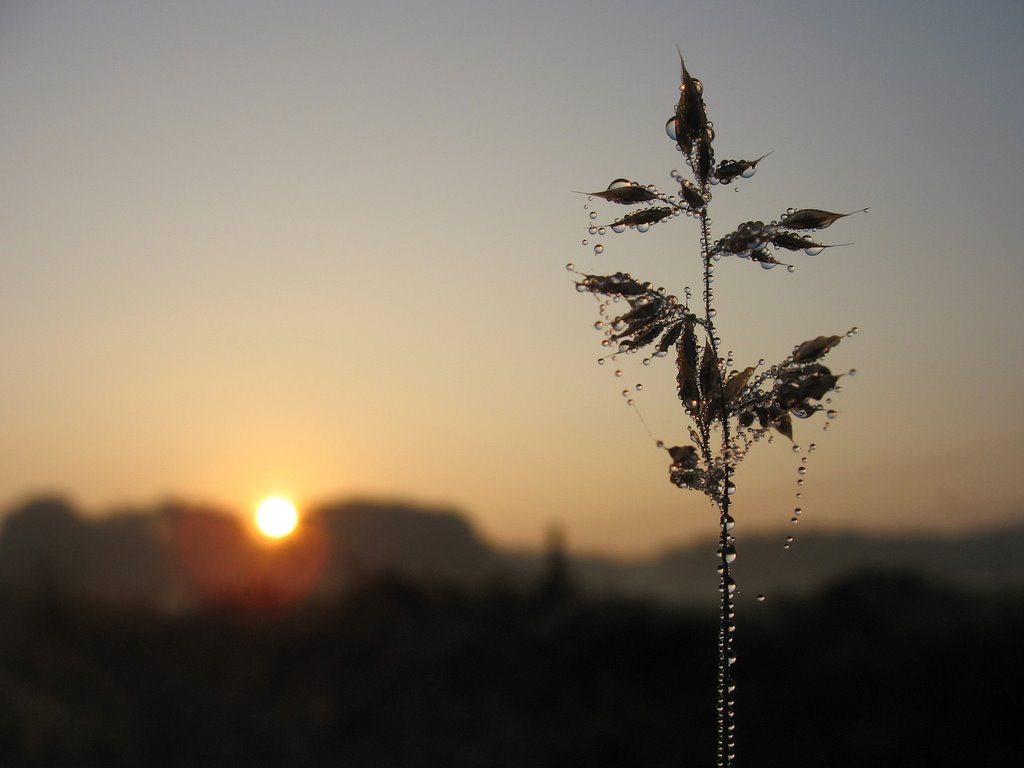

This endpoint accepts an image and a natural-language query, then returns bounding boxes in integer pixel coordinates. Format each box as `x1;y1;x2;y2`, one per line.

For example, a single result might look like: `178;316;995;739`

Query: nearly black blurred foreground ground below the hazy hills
0;574;1024;768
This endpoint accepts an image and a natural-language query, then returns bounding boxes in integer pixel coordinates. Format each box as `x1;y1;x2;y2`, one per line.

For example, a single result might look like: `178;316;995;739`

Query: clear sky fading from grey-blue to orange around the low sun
0;0;1024;556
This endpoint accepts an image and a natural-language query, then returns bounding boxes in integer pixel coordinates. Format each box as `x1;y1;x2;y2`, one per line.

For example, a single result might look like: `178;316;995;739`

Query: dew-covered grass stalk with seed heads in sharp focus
568;53;867;766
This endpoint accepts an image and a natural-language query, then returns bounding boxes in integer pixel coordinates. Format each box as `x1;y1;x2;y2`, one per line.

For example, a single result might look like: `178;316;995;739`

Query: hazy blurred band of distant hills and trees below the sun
0;497;1024;610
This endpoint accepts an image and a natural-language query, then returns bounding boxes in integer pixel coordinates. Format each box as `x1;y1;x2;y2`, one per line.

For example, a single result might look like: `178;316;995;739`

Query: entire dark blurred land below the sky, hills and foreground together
0;498;1024;767
